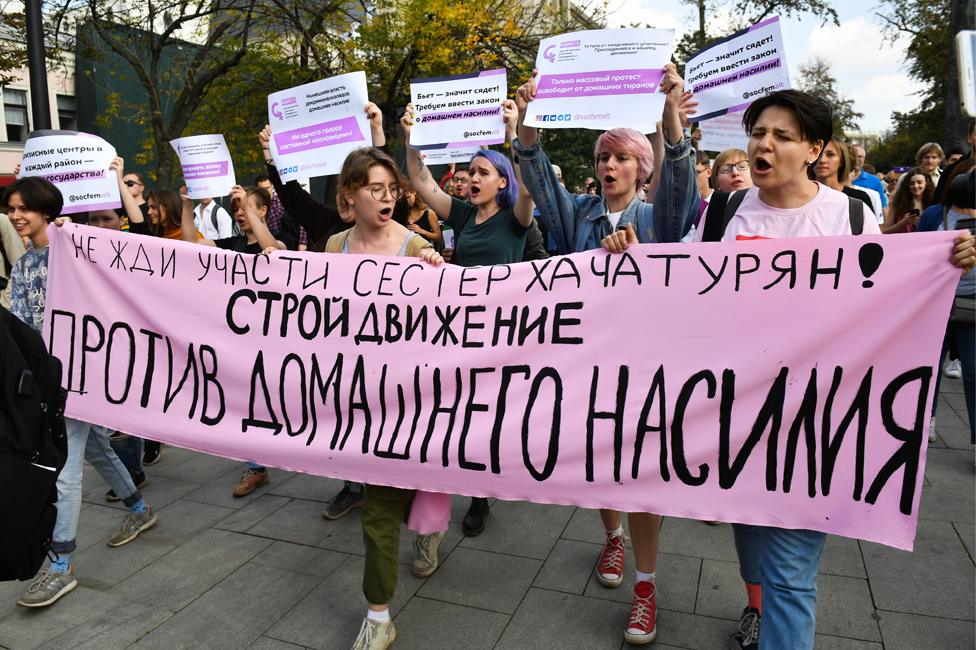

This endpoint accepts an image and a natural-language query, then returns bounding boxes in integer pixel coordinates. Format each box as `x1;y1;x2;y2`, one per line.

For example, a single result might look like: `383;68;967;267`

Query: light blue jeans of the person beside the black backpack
51;418;142;553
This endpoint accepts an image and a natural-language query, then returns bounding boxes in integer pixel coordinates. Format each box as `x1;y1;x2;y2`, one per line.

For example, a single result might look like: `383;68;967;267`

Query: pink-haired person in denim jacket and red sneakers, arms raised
512;64;700;644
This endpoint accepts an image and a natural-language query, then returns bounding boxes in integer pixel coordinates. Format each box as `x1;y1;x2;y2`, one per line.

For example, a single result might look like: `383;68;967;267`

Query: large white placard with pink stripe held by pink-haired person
525;29;674;133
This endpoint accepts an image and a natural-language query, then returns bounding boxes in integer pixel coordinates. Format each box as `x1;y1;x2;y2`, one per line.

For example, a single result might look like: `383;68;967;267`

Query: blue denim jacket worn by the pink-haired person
512;136;700;254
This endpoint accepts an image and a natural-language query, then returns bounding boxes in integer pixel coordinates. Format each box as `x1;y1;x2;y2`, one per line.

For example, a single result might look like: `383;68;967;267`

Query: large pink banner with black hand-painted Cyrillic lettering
45;225;958;549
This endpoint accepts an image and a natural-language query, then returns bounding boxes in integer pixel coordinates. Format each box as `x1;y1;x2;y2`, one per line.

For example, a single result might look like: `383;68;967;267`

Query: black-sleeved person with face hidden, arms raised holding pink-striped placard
258;102;386;520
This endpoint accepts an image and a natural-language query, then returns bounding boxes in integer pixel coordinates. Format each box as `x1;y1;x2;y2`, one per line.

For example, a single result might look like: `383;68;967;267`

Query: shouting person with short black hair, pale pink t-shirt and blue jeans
668;90;976;650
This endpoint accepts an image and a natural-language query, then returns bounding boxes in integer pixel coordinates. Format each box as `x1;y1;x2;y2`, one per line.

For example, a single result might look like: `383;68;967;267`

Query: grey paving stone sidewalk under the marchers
0;380;976;650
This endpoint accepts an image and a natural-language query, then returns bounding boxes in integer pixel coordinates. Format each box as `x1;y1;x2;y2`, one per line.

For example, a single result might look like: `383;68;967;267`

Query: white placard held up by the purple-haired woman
410;68;508;155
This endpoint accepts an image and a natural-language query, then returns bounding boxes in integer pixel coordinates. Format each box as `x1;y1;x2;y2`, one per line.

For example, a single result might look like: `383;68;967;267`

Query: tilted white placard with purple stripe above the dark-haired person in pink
685;16;790;120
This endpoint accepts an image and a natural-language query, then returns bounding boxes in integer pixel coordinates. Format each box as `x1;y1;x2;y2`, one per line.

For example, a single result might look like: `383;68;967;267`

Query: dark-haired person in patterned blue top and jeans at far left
3;176;157;607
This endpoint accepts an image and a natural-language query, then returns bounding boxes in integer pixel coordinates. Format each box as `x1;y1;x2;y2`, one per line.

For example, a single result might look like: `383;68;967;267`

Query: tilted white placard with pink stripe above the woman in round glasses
268;71;370;182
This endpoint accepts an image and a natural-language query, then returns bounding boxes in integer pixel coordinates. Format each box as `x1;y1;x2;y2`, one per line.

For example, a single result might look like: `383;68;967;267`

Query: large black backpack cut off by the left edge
0;307;68;580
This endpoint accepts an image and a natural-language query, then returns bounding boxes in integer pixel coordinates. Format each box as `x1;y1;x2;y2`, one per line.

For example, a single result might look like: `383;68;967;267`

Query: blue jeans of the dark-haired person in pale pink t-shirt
732;524;827;650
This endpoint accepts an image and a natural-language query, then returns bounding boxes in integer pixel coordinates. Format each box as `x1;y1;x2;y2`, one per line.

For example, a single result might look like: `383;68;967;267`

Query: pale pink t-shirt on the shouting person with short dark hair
694;183;881;241
